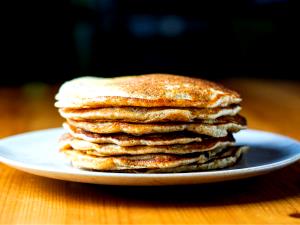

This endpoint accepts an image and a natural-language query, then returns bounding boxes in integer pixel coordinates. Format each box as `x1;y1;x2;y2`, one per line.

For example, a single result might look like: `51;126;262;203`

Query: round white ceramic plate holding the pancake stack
0;128;300;185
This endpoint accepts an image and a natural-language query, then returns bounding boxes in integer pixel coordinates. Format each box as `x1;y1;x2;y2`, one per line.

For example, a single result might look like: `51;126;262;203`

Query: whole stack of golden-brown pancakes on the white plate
55;74;246;173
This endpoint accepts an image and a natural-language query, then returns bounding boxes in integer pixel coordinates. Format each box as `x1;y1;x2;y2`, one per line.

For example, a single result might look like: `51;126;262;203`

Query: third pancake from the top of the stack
67;115;246;137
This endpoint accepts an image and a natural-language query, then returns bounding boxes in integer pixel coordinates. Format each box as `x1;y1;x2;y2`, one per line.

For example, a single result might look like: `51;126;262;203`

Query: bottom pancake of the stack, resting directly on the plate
63;146;245;173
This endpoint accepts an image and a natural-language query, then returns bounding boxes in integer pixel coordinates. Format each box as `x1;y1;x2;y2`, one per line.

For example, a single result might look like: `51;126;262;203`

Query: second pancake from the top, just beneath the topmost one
59;105;241;123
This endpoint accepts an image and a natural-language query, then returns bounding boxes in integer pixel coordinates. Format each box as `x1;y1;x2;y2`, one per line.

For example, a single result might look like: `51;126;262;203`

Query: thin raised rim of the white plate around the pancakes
0;127;300;179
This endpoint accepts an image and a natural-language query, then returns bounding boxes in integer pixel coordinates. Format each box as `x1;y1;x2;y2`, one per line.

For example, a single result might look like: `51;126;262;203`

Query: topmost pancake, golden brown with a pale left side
55;74;241;109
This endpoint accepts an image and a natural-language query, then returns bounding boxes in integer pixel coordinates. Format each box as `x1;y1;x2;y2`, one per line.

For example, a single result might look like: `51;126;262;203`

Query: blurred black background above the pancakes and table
1;0;292;85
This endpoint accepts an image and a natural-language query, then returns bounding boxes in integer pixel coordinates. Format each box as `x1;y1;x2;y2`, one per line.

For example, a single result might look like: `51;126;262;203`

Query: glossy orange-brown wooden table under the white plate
0;79;300;224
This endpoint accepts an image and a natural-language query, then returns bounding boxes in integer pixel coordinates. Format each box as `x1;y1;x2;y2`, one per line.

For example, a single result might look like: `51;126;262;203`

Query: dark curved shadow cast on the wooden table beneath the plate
36;165;300;207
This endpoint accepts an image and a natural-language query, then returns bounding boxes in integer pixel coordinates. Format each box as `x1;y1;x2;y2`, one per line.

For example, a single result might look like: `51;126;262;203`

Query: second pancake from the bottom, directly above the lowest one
60;134;234;156
